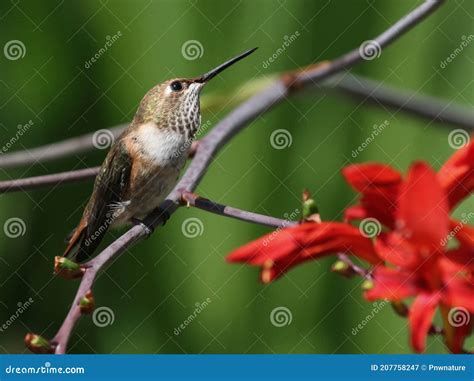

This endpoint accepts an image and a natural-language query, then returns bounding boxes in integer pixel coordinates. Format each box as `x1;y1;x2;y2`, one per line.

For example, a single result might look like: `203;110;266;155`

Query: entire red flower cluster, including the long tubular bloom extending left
228;143;474;352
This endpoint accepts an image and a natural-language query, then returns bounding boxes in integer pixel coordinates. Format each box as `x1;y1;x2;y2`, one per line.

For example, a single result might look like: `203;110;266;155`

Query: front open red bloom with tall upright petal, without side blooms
366;163;474;352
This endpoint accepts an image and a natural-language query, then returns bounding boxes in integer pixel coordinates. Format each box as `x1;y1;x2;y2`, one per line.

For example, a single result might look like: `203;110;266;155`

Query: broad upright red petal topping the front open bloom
397;162;449;254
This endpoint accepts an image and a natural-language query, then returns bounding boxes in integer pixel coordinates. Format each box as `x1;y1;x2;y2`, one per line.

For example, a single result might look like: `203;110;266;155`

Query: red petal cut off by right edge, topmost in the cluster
437;141;474;209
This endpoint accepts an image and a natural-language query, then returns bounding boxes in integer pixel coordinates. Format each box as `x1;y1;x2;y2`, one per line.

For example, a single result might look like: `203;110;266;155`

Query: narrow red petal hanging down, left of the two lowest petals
408;293;441;352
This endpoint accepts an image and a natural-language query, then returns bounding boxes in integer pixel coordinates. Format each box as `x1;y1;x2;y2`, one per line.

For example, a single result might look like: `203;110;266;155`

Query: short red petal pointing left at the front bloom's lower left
365;266;422;301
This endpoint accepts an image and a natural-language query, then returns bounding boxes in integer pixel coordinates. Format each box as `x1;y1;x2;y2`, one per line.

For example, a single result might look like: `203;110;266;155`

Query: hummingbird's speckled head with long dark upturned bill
135;48;257;134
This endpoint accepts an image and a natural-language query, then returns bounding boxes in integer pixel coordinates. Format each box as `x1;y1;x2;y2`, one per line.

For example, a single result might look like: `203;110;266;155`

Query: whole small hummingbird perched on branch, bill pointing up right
64;48;257;262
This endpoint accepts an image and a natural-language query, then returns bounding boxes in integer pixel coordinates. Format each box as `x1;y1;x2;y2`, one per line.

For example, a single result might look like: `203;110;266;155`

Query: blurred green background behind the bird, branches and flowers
0;0;474;353
